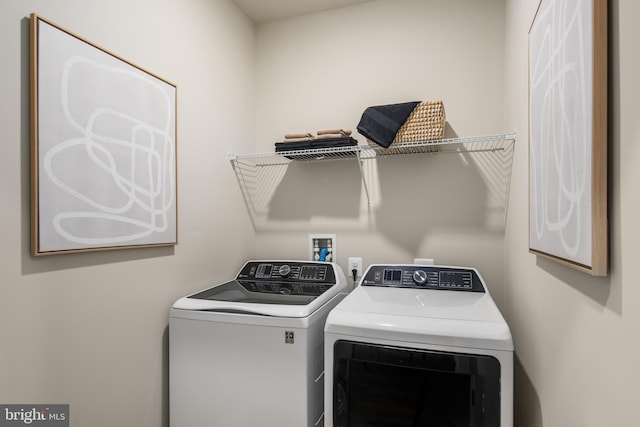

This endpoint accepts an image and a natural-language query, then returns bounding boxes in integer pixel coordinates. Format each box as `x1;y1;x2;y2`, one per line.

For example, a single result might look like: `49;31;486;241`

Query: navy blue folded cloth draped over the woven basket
357;101;420;148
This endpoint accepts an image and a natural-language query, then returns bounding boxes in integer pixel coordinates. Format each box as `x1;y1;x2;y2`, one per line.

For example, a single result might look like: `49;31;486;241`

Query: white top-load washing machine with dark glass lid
169;261;347;427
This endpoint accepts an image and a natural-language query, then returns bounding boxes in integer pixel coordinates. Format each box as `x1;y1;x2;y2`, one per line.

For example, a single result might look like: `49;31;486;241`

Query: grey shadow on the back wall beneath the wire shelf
268;147;488;253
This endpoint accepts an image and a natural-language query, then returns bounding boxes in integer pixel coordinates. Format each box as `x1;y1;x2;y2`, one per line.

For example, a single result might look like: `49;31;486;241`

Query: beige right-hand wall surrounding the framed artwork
504;0;640;427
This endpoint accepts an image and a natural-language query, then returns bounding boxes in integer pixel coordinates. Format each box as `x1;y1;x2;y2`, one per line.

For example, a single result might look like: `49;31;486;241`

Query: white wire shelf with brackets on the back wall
227;132;516;222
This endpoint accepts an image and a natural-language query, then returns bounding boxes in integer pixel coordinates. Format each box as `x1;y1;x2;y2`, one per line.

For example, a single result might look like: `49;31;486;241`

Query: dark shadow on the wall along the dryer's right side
513;357;542;427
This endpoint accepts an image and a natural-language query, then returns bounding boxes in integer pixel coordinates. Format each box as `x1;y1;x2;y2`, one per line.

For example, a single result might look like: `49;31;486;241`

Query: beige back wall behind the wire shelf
251;0;510;303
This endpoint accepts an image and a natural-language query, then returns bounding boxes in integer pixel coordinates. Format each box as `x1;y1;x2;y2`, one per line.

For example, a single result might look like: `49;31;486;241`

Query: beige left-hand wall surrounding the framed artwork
0;0;255;427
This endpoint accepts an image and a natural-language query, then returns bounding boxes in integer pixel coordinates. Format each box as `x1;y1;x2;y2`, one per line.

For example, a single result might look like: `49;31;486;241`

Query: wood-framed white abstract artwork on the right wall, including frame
529;0;608;276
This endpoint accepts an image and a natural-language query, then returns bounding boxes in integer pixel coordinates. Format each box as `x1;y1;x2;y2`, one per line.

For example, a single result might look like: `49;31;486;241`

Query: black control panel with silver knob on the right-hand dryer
360;264;485;292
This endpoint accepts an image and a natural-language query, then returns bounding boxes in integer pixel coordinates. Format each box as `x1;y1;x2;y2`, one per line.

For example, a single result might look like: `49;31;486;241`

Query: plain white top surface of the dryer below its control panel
325;286;513;351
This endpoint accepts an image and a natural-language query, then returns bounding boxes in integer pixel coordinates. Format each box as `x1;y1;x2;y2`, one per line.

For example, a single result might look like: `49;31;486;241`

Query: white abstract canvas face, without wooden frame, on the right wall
529;0;593;266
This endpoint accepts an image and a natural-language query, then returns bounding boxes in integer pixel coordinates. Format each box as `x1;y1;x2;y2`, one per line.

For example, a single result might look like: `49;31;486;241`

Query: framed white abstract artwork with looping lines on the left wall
32;17;177;254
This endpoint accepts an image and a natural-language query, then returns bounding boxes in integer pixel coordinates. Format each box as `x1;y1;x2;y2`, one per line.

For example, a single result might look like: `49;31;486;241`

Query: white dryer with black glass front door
325;265;513;427
